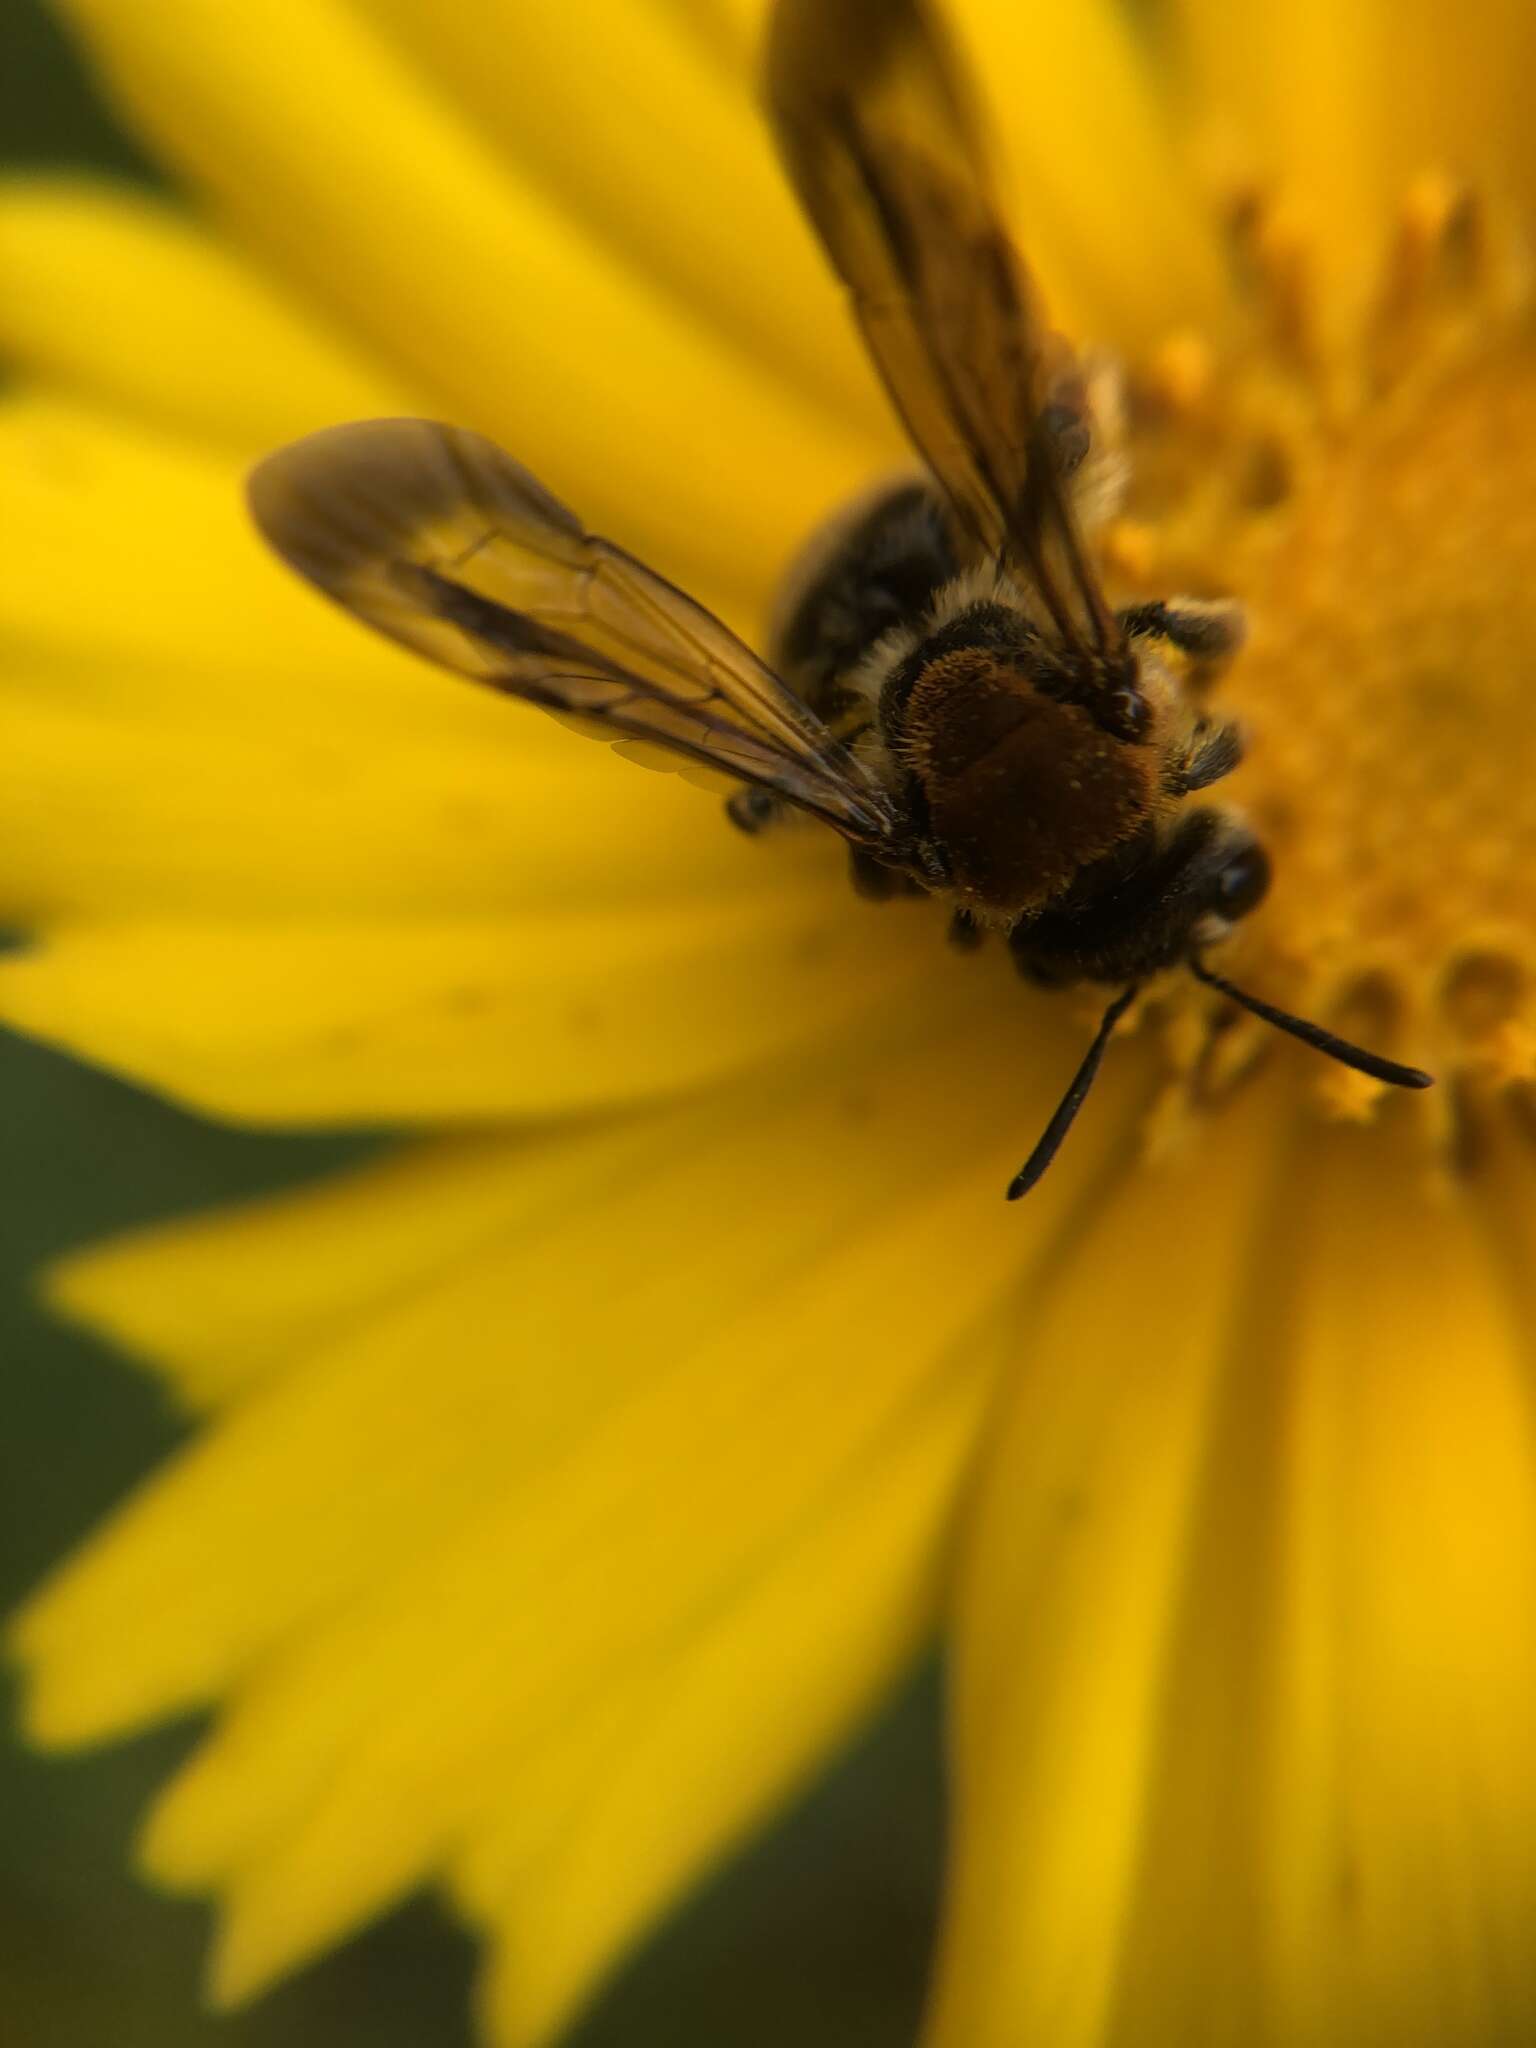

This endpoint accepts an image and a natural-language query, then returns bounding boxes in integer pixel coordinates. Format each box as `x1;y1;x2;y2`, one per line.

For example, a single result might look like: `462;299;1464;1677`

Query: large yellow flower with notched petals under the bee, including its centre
0;0;1536;2048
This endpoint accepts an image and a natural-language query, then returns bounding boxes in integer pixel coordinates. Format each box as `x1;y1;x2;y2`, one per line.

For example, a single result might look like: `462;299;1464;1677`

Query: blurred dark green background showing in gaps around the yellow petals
0;0;942;2048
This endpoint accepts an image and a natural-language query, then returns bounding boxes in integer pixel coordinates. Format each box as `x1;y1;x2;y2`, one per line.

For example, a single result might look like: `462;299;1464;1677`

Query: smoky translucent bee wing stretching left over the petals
248;420;899;854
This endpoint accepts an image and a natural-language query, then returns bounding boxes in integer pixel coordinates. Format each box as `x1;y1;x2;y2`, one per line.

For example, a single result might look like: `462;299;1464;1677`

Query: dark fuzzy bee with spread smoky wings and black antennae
250;0;1430;1198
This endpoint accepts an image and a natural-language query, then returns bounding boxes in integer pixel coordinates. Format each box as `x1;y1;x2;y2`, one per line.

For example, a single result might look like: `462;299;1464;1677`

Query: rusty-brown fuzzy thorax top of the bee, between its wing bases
901;649;1157;911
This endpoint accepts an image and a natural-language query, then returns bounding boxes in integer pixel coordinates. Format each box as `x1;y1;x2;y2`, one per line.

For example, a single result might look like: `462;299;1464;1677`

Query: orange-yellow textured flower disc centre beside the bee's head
1223;321;1536;1077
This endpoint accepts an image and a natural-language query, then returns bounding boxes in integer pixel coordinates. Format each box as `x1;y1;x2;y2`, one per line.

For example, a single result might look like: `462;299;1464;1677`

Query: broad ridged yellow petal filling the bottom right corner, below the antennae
932;1089;1536;2048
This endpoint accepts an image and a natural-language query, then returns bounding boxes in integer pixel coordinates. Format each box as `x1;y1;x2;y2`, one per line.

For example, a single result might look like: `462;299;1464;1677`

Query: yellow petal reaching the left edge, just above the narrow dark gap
0;892;933;1124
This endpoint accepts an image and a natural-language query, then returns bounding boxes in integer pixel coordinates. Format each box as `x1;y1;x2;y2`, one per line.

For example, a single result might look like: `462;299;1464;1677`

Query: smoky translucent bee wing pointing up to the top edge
766;0;1120;653
